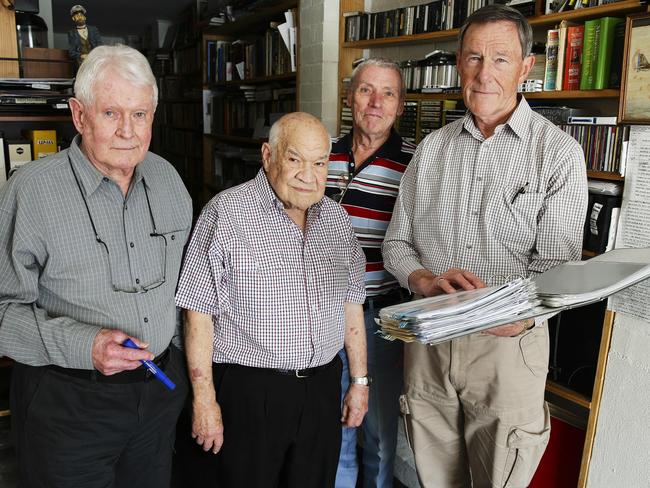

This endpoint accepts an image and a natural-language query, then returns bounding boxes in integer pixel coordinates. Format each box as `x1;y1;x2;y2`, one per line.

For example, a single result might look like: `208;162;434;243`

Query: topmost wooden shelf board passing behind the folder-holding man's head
341;0;645;49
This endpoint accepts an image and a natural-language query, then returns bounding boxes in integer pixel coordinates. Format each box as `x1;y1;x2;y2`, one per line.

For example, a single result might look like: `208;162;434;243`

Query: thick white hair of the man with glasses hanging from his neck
74;44;158;110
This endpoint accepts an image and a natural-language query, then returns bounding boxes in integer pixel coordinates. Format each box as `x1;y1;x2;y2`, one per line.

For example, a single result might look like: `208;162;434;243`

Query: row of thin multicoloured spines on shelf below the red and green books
559;117;630;175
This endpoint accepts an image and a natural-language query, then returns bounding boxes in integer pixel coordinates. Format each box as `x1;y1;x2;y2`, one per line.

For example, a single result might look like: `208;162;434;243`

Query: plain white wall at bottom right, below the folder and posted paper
587;314;650;488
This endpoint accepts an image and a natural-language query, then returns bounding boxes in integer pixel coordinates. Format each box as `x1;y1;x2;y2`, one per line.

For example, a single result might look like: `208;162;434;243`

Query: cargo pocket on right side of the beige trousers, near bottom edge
500;404;551;488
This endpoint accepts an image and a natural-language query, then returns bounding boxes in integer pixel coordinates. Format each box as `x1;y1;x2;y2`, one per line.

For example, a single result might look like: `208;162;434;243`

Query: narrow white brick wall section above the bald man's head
299;0;339;134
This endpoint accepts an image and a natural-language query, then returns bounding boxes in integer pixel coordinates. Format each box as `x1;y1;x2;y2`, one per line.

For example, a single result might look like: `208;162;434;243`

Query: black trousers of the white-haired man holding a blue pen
10;346;189;488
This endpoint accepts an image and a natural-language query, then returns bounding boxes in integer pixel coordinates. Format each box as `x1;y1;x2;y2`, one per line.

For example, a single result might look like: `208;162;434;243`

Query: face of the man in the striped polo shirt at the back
348;65;404;137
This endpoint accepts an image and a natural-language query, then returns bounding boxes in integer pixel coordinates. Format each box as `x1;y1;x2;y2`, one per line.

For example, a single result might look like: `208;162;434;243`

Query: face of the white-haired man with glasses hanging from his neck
70;69;154;174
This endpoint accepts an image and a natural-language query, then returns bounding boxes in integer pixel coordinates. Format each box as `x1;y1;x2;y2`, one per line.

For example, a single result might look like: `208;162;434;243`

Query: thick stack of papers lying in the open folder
375;279;541;344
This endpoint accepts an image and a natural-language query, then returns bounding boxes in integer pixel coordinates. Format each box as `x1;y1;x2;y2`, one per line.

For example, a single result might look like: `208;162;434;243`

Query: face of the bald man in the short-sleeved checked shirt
262;121;329;210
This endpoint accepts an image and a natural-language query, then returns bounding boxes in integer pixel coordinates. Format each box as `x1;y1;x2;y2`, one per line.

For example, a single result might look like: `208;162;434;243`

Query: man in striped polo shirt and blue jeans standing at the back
326;58;415;488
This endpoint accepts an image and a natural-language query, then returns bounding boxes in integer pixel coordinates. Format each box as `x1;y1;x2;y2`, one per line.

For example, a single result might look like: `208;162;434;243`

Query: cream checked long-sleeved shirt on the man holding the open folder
383;98;587;286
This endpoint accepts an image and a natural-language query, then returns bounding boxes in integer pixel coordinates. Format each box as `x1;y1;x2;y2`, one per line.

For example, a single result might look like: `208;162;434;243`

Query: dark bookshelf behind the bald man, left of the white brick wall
200;0;299;206
